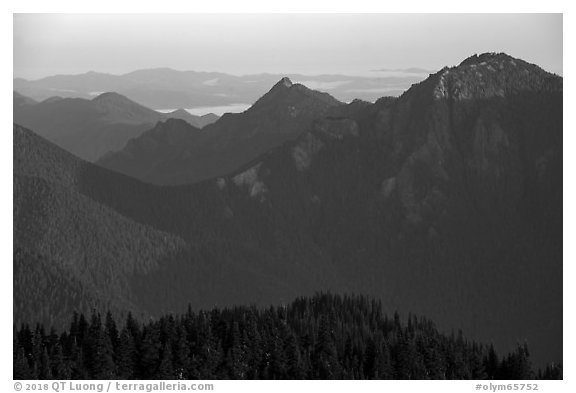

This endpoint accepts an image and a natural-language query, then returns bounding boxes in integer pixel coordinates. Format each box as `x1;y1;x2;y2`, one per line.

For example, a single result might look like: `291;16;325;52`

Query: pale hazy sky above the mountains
14;14;562;79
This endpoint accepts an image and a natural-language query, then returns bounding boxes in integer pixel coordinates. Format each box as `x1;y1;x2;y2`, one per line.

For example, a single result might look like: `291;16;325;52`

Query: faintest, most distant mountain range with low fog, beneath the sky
14;68;425;109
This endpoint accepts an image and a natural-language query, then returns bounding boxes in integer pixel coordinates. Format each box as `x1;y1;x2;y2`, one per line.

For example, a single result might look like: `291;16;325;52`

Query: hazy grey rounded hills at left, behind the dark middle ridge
13;92;218;161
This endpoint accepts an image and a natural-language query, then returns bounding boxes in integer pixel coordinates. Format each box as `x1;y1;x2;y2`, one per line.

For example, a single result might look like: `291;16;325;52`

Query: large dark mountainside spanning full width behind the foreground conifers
14;54;562;362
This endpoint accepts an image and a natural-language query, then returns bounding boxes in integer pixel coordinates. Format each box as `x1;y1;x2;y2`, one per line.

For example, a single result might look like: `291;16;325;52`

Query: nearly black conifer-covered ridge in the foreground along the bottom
13;294;562;380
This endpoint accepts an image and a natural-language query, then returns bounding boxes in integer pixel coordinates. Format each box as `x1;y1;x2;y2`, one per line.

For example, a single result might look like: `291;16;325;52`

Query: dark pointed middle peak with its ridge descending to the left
98;78;341;185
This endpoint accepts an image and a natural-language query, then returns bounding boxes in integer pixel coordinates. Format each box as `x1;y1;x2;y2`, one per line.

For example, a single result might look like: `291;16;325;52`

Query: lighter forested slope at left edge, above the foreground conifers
14;125;184;323
